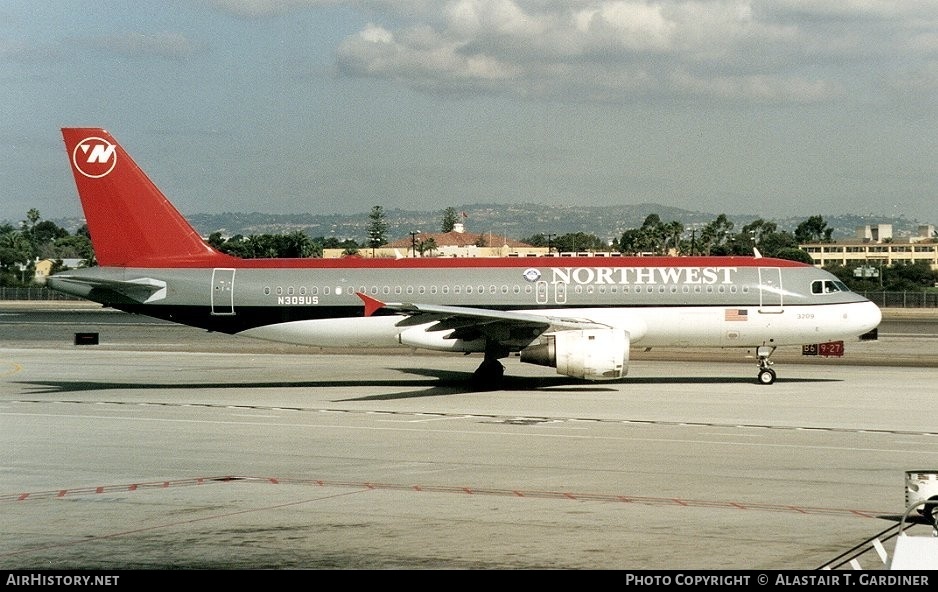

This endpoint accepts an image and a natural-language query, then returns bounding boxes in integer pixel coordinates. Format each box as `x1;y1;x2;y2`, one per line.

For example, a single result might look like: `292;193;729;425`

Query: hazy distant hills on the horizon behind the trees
44;203;922;243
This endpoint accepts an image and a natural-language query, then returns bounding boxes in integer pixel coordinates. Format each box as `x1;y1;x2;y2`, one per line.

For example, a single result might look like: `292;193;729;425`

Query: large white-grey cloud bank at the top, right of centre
337;0;838;103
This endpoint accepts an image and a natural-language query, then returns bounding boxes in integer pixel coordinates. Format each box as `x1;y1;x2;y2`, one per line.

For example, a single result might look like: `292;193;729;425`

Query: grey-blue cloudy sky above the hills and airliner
0;0;938;224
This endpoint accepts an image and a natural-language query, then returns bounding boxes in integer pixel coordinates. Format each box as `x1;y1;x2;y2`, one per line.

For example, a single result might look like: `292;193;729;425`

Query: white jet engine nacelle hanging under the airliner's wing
521;329;629;380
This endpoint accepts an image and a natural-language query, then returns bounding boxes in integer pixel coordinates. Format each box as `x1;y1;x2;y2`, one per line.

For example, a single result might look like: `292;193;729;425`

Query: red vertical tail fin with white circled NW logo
62;128;234;267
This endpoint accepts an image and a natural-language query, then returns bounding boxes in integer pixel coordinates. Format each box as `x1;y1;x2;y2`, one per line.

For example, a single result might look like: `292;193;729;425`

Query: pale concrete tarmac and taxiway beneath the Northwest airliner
0;303;938;570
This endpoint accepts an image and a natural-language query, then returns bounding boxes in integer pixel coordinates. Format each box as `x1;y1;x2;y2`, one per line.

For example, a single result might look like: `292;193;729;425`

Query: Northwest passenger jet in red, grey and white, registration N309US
48;128;881;384
